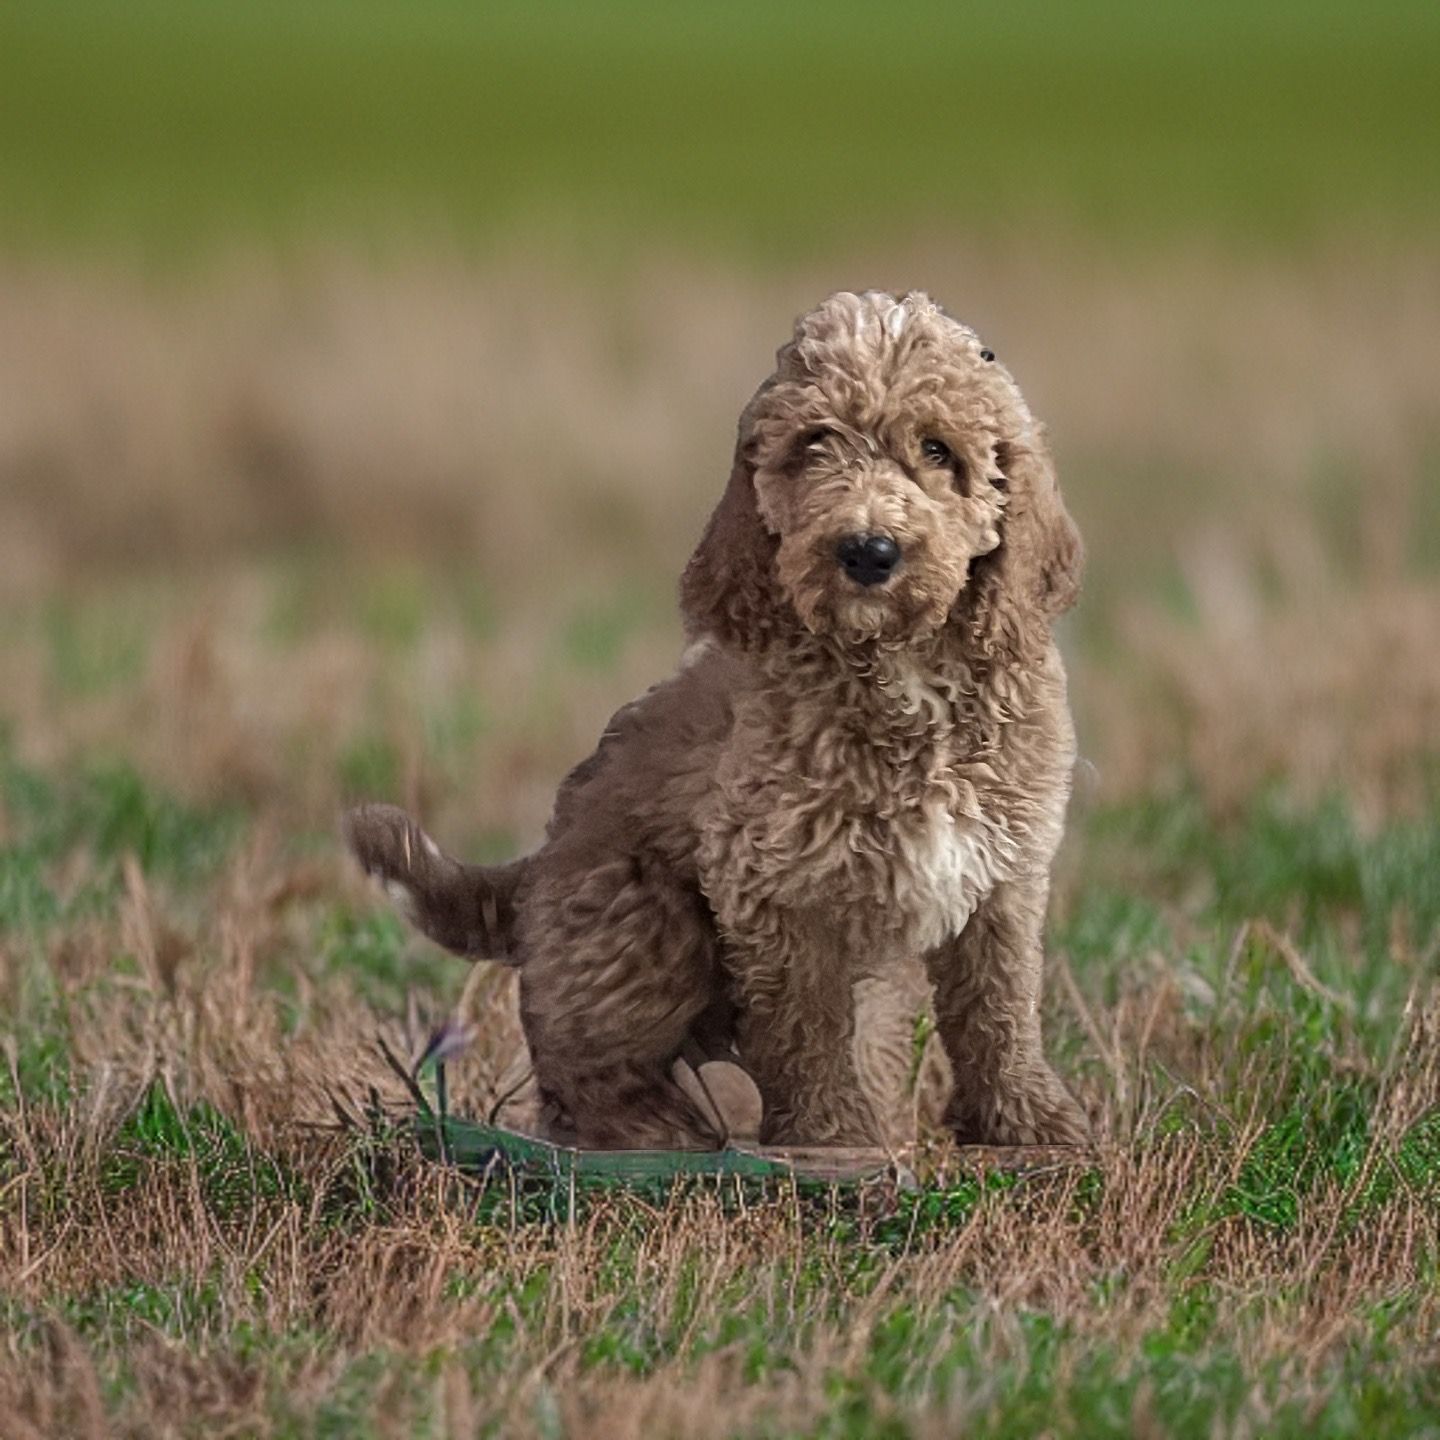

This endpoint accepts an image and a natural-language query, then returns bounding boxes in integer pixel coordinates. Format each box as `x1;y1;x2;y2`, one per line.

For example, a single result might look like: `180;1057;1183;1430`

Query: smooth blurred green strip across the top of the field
0;0;1440;256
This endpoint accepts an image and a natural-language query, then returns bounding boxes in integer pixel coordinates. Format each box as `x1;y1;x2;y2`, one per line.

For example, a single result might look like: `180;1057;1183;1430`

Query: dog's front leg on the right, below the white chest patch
926;877;1090;1145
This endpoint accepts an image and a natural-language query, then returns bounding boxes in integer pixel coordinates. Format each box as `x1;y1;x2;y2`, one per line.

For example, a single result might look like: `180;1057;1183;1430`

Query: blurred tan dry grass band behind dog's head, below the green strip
0;243;1440;588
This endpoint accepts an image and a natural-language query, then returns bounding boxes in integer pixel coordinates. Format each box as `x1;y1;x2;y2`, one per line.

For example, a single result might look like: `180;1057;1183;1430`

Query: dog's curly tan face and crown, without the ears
749;294;1013;641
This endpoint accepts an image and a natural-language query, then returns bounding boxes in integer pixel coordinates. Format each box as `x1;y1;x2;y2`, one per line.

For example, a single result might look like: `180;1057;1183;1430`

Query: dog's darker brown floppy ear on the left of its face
680;439;785;649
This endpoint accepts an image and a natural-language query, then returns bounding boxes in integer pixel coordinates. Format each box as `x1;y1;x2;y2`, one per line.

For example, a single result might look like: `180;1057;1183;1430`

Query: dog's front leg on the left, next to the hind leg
727;927;884;1145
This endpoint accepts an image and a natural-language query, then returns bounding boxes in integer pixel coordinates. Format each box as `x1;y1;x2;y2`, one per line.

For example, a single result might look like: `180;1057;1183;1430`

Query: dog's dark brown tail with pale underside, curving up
343;805;528;965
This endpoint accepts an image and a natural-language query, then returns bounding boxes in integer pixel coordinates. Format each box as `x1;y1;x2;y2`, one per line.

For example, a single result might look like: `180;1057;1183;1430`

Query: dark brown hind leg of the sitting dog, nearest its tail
518;854;726;1149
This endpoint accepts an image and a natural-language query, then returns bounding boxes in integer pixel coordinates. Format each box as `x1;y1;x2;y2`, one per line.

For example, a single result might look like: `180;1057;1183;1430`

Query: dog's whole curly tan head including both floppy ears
681;291;1080;652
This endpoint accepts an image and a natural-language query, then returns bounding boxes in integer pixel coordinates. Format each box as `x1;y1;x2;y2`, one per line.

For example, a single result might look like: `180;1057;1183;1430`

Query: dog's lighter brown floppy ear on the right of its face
962;432;1084;654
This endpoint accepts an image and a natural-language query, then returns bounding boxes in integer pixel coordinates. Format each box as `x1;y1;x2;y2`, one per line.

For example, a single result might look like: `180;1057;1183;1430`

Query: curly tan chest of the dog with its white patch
700;670;1017;959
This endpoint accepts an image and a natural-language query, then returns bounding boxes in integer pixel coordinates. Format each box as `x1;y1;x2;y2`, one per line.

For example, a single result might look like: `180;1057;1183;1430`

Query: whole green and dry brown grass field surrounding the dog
0;0;1440;1440
